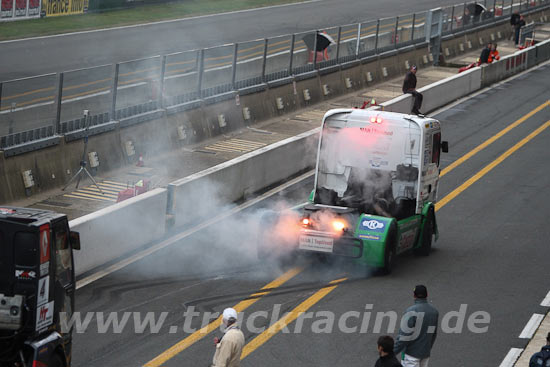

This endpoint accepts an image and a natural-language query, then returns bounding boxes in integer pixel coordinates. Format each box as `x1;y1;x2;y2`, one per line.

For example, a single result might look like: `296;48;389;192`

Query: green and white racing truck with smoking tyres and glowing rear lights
257;109;448;273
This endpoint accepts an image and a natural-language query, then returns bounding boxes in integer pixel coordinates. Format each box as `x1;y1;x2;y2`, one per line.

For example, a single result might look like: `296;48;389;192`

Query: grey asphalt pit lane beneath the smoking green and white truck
73;64;550;367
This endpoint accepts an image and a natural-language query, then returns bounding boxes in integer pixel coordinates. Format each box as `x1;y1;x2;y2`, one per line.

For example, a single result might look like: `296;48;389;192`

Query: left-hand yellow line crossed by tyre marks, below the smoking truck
144;267;304;367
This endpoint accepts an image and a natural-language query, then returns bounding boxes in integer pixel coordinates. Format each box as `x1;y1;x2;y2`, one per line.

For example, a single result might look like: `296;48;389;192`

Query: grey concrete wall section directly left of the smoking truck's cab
168;128;320;227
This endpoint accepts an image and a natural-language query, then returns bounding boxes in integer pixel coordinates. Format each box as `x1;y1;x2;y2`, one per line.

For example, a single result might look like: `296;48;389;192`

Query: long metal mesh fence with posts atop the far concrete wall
0;0;550;149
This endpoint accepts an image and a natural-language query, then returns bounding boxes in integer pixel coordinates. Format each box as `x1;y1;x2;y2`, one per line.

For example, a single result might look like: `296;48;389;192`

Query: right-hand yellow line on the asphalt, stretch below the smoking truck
241;278;347;360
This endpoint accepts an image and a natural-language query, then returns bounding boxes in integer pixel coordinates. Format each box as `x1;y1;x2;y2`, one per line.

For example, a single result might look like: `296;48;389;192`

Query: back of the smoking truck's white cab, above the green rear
314;119;421;216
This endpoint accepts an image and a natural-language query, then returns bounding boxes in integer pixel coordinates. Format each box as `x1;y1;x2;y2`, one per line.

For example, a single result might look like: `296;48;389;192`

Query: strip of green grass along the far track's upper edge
0;0;303;40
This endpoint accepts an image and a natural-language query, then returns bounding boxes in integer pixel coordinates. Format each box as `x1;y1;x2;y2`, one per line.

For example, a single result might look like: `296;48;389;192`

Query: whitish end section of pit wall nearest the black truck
69;189;168;275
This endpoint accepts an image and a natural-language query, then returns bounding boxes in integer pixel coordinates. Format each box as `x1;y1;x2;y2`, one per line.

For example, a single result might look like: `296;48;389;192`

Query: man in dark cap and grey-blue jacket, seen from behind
393;285;439;367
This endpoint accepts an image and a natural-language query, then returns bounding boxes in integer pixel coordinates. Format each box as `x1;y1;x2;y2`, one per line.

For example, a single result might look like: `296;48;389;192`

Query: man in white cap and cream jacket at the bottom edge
212;308;244;367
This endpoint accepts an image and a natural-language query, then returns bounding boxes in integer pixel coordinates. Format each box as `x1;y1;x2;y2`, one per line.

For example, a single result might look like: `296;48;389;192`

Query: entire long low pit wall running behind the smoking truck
69;36;550;275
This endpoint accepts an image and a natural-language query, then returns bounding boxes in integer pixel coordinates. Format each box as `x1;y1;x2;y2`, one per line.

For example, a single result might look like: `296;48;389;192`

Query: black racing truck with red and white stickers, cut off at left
0;207;80;367
